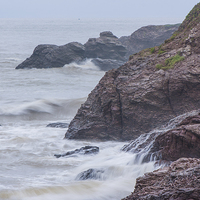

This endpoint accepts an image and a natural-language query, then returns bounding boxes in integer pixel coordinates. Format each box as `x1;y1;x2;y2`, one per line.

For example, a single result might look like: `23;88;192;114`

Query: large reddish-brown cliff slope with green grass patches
66;4;200;140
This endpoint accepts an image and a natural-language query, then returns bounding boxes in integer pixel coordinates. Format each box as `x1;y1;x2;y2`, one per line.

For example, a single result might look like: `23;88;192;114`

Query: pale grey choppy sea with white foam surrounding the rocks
0;18;183;200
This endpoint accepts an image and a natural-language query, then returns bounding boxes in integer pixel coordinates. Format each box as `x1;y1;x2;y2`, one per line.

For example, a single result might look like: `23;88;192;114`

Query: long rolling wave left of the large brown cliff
0;98;86;120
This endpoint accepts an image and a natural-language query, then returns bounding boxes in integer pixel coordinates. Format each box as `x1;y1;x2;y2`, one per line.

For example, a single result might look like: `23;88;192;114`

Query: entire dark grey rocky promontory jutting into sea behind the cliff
16;25;178;71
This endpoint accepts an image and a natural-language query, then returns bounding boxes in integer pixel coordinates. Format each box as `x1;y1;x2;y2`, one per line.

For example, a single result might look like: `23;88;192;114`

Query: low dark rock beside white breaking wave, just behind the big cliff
91;58;124;71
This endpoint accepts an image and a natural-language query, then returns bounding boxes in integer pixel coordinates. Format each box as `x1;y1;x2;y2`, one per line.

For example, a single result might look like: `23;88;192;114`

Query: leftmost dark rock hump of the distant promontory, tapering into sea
16;42;85;69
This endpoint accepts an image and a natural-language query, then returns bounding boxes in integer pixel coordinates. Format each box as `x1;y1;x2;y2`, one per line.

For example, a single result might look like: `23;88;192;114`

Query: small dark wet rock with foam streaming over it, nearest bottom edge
76;169;105;180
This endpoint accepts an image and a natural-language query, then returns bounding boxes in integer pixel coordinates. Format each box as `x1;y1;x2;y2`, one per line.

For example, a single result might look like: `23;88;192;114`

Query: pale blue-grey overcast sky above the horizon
0;0;200;19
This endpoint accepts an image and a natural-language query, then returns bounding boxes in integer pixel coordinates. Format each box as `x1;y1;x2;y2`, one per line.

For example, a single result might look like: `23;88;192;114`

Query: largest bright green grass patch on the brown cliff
156;54;185;70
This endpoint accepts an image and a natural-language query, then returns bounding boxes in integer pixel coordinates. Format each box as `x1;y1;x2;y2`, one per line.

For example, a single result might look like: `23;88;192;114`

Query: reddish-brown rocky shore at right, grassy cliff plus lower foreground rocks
65;3;200;200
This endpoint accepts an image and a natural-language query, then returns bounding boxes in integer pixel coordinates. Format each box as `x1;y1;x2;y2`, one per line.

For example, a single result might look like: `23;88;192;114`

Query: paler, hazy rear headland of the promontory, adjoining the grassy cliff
119;24;180;58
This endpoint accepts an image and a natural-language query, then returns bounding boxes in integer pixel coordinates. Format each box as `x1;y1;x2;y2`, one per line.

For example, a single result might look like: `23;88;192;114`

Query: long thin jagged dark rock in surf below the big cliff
54;146;99;158
